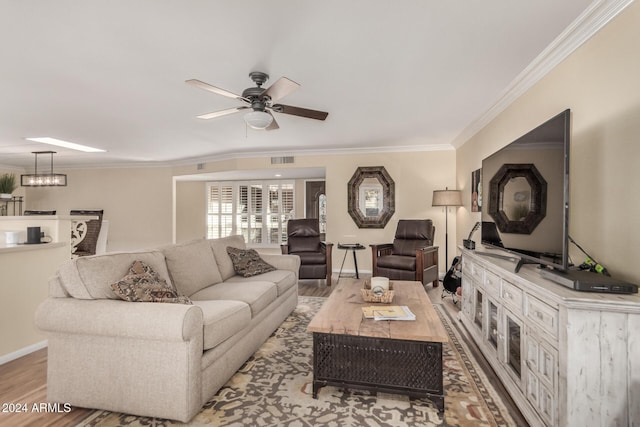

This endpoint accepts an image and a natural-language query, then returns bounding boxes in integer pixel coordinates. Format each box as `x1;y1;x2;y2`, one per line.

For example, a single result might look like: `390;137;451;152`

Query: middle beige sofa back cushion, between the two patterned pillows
162;239;222;296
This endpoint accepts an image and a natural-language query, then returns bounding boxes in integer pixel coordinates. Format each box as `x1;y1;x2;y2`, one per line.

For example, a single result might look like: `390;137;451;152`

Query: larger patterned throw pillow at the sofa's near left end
111;261;193;304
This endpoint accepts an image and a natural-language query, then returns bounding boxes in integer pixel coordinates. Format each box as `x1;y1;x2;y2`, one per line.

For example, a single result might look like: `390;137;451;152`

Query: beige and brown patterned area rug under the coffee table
78;297;515;427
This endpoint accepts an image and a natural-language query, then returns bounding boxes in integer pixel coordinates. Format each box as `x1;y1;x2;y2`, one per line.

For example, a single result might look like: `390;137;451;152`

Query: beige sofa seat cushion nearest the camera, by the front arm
194;300;251;350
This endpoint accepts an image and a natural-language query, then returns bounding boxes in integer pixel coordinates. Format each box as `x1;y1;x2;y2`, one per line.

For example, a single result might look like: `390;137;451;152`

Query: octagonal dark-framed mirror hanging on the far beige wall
347;166;396;228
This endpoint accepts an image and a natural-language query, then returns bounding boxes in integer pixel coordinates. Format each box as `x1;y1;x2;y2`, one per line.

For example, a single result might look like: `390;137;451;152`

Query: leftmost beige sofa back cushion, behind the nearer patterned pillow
58;251;172;299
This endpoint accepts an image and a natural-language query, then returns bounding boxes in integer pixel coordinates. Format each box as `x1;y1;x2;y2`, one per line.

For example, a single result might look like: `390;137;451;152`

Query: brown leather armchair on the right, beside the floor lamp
370;219;438;288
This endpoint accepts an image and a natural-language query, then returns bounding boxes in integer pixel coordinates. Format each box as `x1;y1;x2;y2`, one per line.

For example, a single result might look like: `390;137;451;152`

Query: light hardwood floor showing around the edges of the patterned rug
0;275;527;427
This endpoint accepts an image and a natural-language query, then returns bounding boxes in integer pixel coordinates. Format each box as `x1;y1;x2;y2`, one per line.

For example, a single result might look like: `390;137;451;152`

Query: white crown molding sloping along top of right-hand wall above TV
452;0;634;149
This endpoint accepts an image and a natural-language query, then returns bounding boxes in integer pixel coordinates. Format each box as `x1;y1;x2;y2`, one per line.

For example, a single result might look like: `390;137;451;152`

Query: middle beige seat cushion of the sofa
190;280;278;317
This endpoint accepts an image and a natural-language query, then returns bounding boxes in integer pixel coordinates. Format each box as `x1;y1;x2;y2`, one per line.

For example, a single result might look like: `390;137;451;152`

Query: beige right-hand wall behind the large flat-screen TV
456;2;640;284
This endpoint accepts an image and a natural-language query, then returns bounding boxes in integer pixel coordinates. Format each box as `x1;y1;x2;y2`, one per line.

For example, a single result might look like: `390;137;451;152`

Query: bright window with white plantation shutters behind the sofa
207;181;295;246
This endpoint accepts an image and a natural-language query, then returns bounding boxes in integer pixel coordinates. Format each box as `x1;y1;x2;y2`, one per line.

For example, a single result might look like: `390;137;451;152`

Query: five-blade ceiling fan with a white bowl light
186;71;329;130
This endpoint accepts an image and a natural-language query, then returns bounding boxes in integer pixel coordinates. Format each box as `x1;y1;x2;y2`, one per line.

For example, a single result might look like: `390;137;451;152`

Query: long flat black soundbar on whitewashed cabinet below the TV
540;268;638;294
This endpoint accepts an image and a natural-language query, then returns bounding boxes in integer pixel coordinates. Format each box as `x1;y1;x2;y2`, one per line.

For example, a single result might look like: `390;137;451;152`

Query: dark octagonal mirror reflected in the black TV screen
488;163;547;234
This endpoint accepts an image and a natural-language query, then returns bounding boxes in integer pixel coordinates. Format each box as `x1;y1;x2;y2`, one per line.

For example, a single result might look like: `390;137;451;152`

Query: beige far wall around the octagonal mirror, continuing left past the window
27;150;457;272
